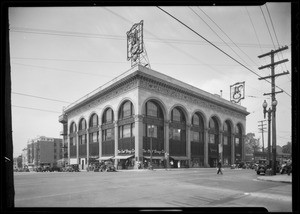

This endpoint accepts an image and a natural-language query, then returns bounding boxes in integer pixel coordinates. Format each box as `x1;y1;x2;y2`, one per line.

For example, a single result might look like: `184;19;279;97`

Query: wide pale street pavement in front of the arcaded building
14;168;292;212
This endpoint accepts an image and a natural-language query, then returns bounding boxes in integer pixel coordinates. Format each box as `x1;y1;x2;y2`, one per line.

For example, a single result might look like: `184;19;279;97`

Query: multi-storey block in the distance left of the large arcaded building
27;136;63;167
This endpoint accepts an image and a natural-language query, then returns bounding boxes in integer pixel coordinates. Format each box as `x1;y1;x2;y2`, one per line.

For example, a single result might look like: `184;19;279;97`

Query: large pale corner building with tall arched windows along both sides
59;65;249;169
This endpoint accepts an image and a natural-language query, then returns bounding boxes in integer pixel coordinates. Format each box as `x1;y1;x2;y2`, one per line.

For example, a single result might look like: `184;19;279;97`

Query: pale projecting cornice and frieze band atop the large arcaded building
64;65;249;118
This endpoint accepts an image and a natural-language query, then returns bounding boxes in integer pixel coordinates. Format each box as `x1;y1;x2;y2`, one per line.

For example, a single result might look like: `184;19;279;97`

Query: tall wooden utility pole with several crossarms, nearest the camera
258;46;289;175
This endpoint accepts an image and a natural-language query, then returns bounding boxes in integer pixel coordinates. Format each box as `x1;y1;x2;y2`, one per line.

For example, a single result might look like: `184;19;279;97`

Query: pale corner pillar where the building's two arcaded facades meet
134;115;144;169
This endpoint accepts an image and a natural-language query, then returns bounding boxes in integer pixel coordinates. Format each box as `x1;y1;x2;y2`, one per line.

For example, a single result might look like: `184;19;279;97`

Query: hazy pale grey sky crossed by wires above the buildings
9;3;292;157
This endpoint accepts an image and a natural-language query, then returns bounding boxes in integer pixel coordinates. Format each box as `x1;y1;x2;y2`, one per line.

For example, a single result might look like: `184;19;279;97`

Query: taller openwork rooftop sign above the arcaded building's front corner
127;20;144;67
